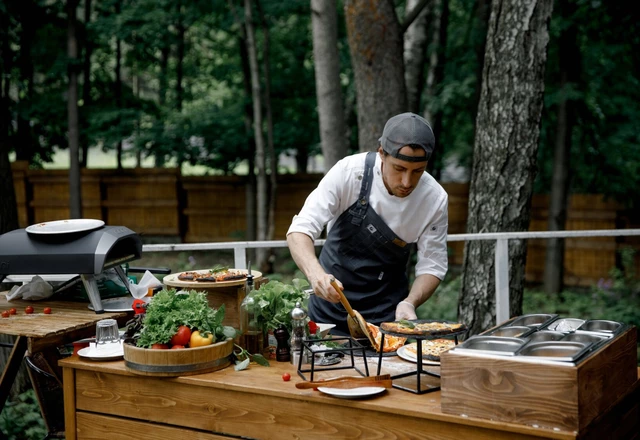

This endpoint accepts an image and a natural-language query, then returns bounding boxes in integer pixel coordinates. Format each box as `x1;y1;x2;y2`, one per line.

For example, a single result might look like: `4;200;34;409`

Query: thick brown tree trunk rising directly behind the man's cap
345;0;407;151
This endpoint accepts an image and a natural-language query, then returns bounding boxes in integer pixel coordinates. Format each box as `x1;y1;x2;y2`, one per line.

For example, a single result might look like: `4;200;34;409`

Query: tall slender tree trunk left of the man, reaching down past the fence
244;0;268;267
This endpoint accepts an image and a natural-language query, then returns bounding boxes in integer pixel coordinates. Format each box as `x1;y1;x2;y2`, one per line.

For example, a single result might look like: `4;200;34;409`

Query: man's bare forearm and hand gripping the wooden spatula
287;232;342;303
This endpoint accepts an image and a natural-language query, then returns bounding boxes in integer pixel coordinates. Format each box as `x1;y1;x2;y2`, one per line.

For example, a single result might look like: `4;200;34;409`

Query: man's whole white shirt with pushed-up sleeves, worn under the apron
287;153;448;280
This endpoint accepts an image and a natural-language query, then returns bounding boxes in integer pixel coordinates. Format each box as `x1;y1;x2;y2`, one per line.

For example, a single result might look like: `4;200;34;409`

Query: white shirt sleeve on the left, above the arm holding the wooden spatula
287;160;347;240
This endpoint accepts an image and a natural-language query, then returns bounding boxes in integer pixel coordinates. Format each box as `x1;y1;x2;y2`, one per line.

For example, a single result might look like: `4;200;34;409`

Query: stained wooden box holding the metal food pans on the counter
441;327;638;432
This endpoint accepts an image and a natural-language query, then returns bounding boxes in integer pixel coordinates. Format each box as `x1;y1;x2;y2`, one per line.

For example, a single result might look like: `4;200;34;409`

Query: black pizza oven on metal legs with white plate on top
0;226;142;313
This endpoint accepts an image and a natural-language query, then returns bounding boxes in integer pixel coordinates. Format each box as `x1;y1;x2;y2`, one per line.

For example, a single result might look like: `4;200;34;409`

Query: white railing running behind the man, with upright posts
142;229;640;323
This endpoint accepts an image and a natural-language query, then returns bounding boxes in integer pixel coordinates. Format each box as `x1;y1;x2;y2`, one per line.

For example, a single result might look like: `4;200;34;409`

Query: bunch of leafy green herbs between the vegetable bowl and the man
248;278;309;333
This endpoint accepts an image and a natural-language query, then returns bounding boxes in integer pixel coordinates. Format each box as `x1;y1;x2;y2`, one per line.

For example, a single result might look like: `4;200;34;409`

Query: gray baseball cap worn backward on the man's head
378;113;436;162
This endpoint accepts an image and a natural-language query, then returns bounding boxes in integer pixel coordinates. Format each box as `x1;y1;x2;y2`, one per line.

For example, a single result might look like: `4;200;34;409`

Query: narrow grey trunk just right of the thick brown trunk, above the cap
404;0;430;114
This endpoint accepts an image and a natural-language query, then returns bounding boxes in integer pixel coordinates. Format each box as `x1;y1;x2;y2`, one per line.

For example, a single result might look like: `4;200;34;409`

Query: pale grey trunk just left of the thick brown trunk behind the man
311;0;348;173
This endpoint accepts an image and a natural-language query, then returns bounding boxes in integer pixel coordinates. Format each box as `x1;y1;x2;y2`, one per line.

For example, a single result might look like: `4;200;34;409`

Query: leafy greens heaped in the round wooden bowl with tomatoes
136;289;237;348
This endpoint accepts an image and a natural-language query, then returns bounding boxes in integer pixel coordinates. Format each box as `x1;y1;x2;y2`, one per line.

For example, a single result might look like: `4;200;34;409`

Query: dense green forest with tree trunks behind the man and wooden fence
0;0;640;436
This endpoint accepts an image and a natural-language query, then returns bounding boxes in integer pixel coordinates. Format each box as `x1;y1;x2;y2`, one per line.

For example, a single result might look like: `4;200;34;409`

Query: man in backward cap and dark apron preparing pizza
287;113;448;335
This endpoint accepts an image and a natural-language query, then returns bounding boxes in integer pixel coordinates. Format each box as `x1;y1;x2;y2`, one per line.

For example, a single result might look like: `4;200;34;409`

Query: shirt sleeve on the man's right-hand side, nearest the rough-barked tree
416;192;449;280
